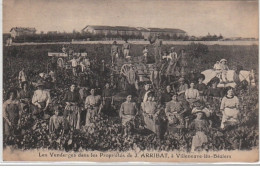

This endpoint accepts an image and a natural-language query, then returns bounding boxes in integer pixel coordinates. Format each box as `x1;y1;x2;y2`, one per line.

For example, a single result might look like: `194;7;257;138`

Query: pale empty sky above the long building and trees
3;0;258;38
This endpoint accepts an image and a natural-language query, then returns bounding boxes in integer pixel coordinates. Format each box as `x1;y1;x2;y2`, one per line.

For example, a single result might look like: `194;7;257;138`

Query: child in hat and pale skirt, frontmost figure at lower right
191;110;208;151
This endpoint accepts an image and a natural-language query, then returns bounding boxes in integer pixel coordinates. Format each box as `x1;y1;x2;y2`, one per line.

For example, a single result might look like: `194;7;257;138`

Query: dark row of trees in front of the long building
5;31;223;43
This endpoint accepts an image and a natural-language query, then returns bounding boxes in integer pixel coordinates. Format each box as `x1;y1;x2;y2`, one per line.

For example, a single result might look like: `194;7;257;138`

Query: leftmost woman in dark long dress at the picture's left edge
3;90;19;139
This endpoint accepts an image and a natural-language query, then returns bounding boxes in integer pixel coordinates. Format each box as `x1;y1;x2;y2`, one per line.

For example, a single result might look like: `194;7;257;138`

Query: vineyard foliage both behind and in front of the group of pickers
3;44;259;151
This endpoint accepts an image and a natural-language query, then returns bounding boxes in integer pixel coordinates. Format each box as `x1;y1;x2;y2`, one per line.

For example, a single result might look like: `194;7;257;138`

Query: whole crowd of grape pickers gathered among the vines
3;40;242;150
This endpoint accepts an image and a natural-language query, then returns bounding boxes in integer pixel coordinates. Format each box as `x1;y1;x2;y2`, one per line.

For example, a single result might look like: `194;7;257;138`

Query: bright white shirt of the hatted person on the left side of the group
32;90;51;106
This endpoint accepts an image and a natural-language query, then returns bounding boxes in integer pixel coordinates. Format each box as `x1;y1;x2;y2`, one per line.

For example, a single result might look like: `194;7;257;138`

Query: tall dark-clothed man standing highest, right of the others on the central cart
150;33;162;64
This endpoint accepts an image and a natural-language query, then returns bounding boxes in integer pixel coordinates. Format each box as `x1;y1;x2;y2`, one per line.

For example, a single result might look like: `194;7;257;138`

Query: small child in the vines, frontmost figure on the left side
49;106;68;134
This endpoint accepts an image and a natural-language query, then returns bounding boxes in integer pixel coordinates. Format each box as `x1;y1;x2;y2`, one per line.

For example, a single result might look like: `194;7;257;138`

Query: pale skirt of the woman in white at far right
220;108;239;128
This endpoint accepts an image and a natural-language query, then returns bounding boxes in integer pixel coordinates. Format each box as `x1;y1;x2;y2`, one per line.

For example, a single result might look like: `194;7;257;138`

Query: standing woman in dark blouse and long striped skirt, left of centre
64;84;80;130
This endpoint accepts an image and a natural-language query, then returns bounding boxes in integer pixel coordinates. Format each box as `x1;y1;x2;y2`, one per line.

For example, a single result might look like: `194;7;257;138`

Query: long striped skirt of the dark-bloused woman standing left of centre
64;105;80;130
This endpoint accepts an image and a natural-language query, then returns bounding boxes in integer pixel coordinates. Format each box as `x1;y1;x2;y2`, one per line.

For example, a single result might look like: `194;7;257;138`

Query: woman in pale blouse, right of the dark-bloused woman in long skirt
85;89;101;126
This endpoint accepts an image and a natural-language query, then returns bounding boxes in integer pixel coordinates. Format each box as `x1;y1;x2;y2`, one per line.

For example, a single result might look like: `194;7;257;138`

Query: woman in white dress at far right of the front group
220;88;239;129
